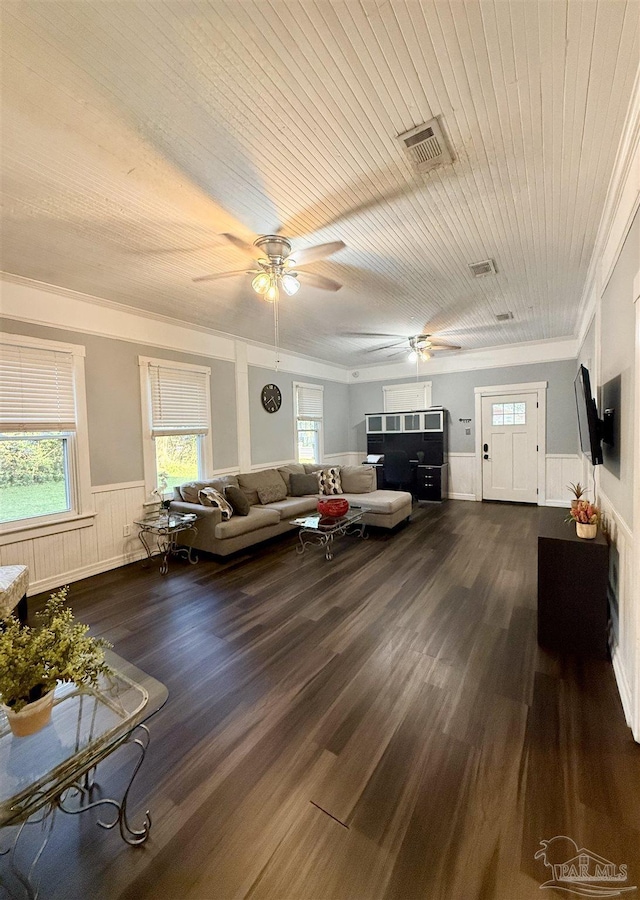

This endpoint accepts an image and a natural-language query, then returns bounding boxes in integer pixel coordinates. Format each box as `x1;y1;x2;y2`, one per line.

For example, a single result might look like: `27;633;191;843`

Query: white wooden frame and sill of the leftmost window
0;332;95;546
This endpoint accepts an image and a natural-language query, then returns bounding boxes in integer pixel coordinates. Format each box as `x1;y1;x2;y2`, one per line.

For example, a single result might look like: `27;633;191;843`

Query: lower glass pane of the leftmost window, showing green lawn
0;434;71;522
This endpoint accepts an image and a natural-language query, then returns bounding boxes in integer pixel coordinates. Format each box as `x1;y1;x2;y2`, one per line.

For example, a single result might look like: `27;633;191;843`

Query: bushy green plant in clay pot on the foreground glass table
0;587;111;737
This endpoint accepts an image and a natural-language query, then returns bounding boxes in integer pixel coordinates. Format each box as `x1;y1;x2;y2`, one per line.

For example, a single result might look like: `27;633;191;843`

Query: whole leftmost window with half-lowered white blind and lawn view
0;334;91;531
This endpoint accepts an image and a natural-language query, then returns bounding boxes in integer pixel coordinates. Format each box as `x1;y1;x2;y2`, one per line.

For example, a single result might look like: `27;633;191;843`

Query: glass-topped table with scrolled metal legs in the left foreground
0;651;168;898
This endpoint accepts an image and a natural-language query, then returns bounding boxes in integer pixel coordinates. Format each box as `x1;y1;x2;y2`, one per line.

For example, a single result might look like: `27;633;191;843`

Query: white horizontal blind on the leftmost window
0;343;76;431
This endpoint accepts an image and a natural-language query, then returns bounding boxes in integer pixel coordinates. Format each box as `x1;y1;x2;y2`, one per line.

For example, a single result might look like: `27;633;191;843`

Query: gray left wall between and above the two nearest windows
0;319;238;486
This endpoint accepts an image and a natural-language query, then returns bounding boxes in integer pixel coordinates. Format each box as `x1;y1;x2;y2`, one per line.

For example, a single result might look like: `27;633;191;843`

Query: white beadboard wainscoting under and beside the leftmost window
0;483;145;594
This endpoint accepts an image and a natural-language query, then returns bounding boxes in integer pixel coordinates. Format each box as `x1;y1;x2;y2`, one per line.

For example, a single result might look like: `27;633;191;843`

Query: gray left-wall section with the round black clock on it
249;366;349;465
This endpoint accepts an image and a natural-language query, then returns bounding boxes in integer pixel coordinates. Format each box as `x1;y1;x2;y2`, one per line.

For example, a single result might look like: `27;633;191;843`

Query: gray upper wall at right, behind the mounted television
598;207;640;528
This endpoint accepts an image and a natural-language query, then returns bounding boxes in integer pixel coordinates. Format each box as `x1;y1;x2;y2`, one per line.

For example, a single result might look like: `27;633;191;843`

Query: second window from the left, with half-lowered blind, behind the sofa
139;357;211;494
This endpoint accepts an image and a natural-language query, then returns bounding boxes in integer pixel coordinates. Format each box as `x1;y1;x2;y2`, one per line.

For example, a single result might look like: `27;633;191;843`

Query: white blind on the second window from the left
149;364;209;437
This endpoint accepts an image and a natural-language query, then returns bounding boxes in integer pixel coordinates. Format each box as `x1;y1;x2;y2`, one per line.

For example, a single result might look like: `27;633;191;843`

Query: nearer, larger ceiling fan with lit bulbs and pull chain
193;234;346;303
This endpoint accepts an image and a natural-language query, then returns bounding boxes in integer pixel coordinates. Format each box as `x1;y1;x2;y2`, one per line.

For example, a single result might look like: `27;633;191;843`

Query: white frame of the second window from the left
138;356;213;503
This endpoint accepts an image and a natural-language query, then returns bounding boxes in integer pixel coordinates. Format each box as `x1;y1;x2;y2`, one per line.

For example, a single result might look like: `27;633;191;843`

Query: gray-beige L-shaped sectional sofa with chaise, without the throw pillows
171;463;412;556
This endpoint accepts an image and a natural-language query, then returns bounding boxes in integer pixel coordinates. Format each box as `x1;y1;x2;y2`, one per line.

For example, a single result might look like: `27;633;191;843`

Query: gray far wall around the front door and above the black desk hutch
349;360;578;453
